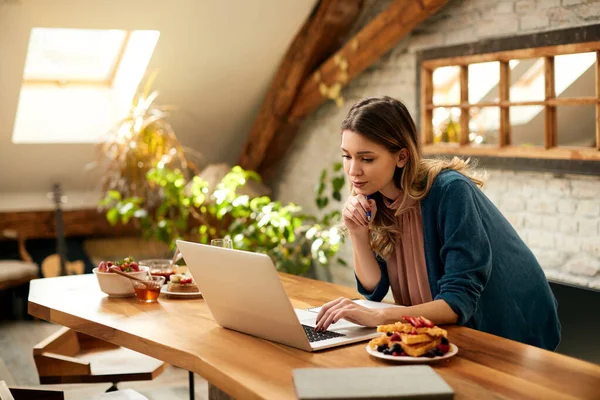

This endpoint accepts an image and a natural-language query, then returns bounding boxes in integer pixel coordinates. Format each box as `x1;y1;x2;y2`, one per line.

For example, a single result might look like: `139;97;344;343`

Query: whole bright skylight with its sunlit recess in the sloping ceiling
13;28;160;143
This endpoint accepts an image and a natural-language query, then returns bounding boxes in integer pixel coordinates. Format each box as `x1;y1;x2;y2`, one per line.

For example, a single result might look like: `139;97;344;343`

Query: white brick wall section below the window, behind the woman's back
483;170;600;286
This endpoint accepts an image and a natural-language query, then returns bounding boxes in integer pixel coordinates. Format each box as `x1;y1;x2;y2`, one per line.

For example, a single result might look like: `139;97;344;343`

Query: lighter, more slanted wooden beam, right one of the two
258;0;448;180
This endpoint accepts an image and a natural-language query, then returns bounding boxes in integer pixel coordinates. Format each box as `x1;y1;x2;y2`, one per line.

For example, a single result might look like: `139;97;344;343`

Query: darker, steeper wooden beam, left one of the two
238;0;363;170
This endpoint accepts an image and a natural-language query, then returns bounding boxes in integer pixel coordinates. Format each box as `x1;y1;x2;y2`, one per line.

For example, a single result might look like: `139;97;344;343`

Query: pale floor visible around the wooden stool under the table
0;321;208;400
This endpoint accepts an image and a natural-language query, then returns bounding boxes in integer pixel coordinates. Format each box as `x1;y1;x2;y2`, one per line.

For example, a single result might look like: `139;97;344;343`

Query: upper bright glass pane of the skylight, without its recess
23;28;129;85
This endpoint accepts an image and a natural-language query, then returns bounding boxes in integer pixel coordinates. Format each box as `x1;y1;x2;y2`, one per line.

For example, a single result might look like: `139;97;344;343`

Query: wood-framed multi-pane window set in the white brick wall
420;35;600;161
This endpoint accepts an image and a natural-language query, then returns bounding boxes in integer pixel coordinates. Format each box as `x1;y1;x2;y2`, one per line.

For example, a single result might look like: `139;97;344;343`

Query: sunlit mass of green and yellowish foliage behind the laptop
95;74;344;274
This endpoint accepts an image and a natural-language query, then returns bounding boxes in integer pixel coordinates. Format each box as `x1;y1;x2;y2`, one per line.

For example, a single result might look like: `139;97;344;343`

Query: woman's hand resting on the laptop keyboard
315;297;383;331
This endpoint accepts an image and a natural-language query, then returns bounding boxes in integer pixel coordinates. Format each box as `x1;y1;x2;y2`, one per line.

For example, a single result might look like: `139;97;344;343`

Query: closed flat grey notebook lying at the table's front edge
293;365;454;400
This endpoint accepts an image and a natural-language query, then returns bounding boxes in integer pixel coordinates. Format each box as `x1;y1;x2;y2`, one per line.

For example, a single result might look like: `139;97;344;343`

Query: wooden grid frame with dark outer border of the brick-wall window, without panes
416;24;600;175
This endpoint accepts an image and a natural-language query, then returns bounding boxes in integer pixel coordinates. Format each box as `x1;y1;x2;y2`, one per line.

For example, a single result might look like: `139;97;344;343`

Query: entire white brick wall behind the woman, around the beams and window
274;0;600;288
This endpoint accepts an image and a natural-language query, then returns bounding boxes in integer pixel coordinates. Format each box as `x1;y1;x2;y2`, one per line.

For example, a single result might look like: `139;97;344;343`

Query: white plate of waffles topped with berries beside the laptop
367;317;458;363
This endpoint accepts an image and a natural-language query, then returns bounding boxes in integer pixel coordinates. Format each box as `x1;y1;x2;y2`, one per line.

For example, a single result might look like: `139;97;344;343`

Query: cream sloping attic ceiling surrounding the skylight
0;0;316;199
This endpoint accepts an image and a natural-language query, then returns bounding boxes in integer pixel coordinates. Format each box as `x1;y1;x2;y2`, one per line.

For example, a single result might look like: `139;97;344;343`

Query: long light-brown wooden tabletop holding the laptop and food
29;274;600;400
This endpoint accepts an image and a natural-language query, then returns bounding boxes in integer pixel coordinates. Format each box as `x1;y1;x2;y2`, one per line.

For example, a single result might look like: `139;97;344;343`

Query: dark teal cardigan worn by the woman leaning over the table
356;171;560;350
